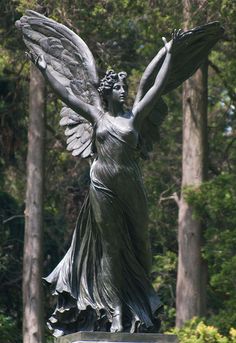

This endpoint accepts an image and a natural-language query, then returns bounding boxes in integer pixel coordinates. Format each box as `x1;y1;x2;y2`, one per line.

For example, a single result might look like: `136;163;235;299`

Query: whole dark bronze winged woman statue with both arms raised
16;11;222;336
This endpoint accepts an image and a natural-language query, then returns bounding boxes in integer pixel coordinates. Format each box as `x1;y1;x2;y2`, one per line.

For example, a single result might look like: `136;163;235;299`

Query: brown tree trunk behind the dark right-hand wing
176;0;207;327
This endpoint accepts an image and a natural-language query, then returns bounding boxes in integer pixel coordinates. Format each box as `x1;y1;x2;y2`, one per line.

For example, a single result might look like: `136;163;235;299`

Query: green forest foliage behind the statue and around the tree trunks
0;0;236;343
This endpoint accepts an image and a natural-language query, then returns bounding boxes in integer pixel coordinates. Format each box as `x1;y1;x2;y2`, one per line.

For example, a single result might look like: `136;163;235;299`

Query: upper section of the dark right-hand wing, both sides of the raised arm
134;21;224;104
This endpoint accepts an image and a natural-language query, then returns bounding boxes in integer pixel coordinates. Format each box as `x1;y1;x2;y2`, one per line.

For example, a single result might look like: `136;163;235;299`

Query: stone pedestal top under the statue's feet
55;332;178;343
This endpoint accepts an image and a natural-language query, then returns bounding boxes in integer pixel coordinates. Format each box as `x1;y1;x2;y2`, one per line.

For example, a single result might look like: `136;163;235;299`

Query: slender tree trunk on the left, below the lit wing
23;64;45;343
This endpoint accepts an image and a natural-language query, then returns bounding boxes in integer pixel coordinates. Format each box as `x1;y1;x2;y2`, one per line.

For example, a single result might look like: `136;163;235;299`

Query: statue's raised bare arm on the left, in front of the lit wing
28;54;98;124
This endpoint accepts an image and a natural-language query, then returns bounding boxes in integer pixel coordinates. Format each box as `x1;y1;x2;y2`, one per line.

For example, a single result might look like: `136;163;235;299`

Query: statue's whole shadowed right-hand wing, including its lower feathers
134;22;224;158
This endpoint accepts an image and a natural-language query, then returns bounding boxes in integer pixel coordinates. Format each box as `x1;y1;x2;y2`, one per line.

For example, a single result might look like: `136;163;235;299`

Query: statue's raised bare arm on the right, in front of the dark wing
133;30;181;130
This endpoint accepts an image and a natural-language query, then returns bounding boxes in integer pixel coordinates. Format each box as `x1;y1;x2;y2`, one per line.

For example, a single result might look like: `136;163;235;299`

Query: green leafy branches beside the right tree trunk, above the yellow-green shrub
185;173;236;332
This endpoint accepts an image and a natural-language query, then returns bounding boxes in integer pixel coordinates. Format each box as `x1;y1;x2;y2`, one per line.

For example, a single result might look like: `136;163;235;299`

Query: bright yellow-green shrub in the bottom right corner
171;318;236;343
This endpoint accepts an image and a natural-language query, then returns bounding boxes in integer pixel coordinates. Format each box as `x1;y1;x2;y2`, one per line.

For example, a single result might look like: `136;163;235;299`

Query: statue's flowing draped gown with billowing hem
46;114;162;335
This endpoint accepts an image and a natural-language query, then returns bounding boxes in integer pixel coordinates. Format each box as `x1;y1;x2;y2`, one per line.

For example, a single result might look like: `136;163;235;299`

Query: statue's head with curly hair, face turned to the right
98;70;128;104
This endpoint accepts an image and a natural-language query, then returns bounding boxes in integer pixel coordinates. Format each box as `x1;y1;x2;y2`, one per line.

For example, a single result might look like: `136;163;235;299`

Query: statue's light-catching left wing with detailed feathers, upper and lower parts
16;11;102;158
